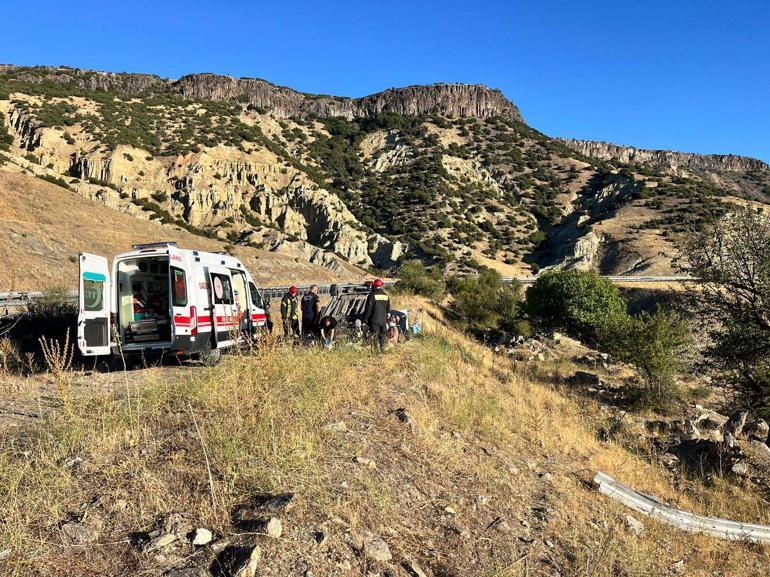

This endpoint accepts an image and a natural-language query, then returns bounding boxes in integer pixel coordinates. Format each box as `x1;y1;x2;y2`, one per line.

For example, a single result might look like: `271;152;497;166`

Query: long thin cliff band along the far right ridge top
559;138;770;172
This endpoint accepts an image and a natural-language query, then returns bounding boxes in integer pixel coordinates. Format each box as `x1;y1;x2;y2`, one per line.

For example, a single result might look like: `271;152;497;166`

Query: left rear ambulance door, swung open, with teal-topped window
78;253;111;356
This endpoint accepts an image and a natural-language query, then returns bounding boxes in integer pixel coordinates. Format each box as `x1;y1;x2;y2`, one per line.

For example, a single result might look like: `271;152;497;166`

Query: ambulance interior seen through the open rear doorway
117;256;171;345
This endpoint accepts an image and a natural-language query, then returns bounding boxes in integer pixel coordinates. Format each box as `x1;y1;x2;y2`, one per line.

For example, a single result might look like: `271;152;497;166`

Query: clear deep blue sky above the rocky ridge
0;0;770;161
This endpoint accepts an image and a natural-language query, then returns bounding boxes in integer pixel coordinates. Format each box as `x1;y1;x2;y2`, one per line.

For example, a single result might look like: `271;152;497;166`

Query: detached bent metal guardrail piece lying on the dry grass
594;471;770;543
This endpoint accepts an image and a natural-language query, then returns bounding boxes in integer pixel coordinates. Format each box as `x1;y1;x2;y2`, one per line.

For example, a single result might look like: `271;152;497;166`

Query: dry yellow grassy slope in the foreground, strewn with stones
0;302;770;577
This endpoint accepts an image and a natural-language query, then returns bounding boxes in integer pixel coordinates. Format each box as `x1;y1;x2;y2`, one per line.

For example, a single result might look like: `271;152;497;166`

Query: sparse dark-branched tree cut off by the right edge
680;207;770;408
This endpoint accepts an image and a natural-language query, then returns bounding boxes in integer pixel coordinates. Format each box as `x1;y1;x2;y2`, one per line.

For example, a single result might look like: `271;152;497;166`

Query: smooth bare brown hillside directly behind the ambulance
0;171;364;291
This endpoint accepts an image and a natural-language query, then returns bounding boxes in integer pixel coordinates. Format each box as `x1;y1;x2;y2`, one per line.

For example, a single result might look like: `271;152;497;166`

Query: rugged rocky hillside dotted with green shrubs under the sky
0;66;770;275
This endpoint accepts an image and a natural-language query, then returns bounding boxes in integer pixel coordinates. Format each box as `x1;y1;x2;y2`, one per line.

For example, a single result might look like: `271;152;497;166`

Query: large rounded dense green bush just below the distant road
526;270;626;343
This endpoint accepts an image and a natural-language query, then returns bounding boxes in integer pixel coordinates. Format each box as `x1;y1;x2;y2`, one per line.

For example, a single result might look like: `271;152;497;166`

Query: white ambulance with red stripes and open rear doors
77;242;266;360
